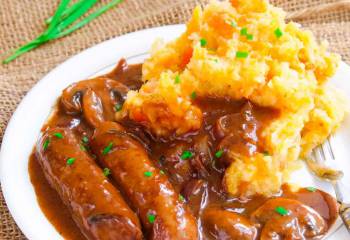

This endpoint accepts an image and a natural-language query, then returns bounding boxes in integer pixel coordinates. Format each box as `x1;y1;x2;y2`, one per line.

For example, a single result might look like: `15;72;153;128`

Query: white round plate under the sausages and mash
0;25;350;240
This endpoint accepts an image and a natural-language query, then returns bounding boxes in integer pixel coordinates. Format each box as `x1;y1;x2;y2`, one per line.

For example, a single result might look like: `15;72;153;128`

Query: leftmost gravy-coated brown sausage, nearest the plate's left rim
36;127;142;240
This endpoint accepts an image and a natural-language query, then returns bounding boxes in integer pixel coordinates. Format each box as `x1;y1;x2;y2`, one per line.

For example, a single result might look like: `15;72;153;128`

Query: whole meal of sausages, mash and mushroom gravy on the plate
29;0;347;240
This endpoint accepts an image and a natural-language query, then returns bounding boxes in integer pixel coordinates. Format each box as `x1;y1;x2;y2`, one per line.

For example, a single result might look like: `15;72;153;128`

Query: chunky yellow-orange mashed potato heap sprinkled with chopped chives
117;0;345;196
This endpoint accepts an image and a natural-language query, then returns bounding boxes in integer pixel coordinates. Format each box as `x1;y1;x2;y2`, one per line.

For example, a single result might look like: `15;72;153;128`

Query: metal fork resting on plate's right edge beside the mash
306;136;350;234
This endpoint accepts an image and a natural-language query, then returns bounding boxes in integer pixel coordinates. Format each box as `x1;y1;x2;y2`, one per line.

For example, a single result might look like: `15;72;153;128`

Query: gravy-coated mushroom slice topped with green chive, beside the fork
251;198;327;240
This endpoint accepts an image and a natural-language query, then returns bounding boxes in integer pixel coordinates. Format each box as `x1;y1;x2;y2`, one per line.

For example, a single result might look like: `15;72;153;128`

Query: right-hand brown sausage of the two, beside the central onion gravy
91;122;198;240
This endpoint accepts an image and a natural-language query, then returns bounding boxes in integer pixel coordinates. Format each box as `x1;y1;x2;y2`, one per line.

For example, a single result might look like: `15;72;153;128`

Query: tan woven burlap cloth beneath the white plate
0;0;350;239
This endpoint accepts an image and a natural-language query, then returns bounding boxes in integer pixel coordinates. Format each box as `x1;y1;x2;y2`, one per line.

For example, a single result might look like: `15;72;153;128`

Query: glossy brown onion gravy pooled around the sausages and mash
29;61;337;239
